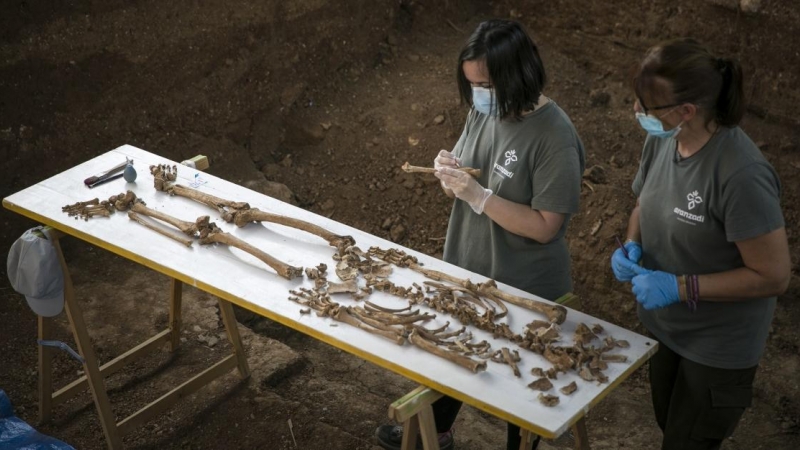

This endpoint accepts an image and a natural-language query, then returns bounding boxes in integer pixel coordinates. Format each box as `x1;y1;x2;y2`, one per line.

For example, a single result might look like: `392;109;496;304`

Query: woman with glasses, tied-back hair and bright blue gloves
611;39;791;449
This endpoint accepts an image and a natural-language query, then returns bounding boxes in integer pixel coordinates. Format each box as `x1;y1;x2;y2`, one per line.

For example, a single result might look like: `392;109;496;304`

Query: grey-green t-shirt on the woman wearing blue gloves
633;127;784;369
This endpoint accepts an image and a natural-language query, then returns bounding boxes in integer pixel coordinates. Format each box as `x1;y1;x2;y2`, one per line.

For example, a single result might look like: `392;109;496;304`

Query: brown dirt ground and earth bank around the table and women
0;0;800;450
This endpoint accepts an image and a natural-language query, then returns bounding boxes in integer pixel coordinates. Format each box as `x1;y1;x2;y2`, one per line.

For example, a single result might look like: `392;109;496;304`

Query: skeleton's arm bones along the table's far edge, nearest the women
369;247;567;324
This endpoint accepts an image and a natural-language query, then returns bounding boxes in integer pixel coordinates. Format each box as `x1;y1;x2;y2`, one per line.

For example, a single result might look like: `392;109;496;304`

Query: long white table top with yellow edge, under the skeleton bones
3;145;657;438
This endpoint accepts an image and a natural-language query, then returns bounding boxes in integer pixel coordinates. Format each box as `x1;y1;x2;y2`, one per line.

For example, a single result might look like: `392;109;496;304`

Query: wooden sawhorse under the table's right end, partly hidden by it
389;293;589;450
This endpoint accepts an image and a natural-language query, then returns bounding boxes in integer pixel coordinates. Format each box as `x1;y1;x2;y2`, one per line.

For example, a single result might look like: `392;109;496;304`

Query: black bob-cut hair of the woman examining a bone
456;19;547;120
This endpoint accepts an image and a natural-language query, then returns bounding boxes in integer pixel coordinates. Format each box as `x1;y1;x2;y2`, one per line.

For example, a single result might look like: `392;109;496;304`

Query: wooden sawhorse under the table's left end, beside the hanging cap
39;228;250;450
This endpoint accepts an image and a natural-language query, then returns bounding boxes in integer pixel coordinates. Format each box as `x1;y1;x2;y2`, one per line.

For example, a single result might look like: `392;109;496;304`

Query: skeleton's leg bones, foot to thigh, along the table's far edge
150;165;355;253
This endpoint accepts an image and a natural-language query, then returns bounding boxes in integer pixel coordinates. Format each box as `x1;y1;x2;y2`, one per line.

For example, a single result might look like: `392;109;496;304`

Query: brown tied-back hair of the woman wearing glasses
633;38;745;127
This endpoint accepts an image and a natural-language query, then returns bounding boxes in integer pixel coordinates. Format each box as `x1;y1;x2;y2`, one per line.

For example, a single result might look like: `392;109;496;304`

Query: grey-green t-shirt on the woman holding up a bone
444;101;584;300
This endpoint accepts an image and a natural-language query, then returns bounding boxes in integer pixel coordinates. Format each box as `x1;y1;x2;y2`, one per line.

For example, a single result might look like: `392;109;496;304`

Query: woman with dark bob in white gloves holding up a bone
377;20;584;450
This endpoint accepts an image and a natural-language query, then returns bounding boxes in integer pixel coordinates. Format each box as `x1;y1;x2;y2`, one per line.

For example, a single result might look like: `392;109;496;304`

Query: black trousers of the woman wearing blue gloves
650;344;758;450
